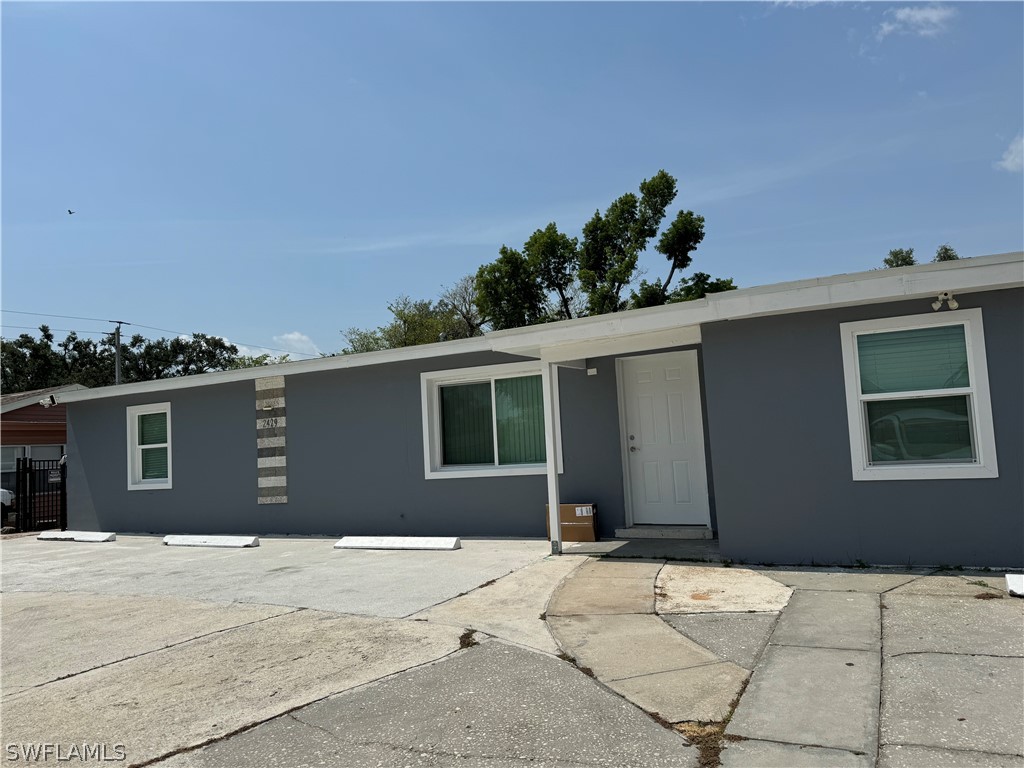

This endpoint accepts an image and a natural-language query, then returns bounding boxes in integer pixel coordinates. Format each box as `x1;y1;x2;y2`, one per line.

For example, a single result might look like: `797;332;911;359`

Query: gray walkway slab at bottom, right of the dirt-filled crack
726;644;881;755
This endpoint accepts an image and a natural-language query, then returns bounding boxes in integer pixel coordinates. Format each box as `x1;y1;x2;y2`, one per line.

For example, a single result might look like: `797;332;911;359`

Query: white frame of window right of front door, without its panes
840;308;999;480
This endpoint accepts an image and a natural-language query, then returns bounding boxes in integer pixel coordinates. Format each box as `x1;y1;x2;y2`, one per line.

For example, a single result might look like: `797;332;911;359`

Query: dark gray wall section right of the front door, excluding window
702;290;1024;566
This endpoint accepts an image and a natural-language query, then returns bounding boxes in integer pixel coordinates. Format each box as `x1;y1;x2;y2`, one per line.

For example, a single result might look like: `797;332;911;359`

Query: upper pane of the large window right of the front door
857;325;971;394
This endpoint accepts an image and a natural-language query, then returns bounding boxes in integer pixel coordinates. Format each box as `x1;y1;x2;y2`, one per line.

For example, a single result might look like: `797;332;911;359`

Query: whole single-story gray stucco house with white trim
58;253;1024;566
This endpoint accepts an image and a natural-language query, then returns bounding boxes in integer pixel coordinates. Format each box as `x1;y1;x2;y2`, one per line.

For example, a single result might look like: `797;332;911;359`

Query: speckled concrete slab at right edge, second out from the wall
882;593;1024;656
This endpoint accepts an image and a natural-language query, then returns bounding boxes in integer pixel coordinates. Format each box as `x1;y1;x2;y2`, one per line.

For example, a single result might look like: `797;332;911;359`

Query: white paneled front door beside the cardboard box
618;350;711;525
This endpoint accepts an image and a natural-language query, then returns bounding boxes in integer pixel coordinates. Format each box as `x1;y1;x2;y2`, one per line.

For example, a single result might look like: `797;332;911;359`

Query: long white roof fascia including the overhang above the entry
51;252;1024;402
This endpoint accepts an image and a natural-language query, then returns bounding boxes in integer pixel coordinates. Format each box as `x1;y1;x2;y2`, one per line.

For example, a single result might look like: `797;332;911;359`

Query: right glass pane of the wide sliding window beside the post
495;376;545;464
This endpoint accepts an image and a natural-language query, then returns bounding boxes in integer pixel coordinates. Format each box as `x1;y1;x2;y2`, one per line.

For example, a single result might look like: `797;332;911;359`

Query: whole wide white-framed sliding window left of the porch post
422;364;561;477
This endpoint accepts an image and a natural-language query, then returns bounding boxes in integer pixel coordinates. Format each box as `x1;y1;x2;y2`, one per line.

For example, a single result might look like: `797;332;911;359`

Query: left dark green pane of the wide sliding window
440;382;495;466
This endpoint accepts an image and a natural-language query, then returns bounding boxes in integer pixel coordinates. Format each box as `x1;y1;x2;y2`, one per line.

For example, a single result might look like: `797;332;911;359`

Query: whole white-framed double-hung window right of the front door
840;309;998;480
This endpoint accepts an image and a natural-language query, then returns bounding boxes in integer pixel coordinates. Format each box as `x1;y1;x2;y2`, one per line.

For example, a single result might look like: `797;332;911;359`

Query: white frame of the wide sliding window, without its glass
420;362;562;480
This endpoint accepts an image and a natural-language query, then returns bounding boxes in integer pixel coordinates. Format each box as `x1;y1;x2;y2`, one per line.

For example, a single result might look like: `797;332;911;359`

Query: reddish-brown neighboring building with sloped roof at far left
0;384;86;490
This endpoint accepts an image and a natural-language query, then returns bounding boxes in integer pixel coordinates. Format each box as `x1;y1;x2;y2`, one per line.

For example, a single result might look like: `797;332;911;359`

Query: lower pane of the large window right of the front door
864;395;977;464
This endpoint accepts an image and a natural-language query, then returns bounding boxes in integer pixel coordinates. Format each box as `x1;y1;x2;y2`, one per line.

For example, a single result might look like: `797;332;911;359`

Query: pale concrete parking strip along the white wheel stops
2;536;551;617
